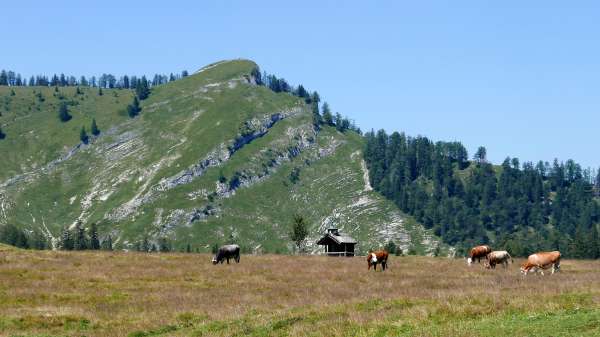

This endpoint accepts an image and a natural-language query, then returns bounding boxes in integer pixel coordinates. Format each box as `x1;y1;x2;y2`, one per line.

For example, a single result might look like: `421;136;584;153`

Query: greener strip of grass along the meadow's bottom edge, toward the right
123;300;600;337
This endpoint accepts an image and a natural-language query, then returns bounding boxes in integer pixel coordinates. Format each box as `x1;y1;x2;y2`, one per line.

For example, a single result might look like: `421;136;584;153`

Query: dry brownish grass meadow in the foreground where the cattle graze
0;246;600;336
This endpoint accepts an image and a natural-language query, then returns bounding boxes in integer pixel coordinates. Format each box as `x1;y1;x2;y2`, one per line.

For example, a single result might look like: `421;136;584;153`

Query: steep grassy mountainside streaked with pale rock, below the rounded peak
0;60;446;253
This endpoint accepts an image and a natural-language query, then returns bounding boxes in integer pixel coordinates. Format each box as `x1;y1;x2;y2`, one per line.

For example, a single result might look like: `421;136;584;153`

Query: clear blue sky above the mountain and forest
0;0;600;168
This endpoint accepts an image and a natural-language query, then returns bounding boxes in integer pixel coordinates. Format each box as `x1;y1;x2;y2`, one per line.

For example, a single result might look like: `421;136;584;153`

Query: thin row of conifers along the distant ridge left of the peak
0;69;189;89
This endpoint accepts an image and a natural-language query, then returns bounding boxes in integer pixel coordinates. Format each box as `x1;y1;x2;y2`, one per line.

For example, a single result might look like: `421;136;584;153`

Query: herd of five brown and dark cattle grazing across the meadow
212;245;560;275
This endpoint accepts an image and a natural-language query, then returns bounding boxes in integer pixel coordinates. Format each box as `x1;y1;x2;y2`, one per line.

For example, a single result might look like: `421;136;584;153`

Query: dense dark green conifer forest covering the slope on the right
364;130;600;258
